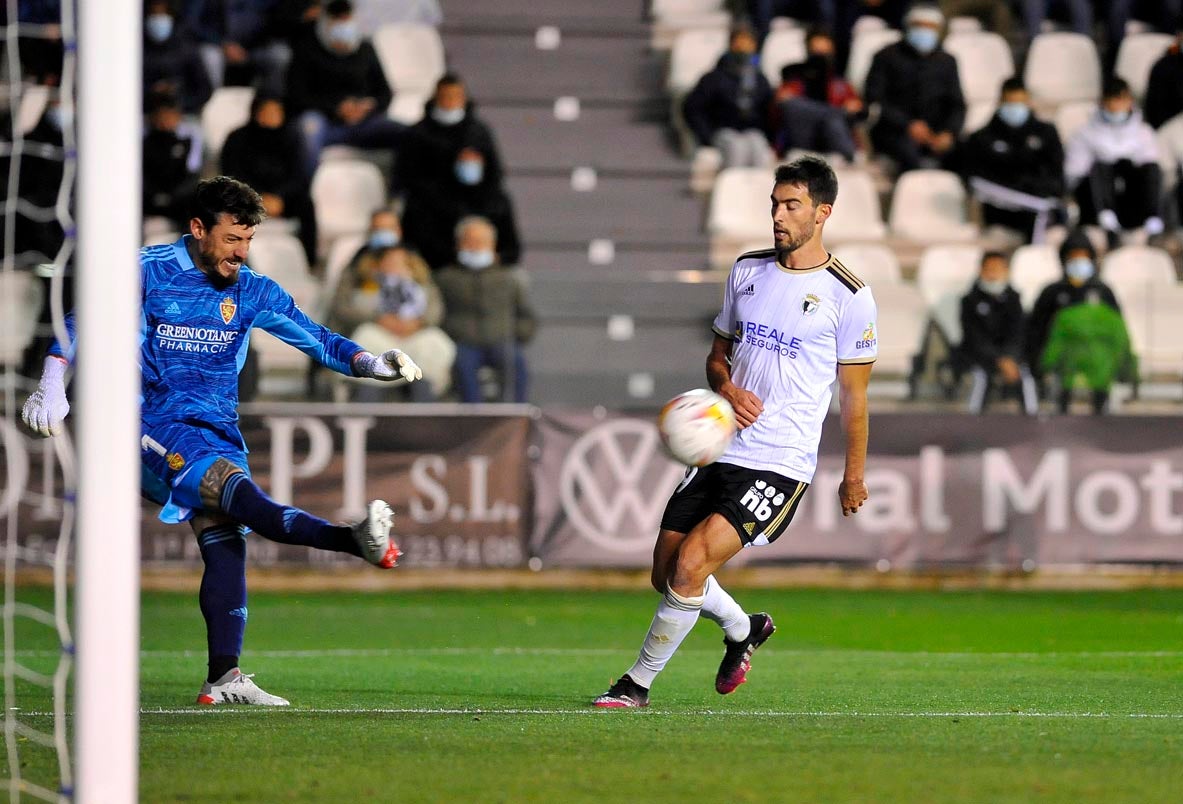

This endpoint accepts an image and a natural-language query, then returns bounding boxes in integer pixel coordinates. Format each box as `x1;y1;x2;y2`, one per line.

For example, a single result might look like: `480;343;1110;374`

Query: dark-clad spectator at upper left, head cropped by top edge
181;0;300;95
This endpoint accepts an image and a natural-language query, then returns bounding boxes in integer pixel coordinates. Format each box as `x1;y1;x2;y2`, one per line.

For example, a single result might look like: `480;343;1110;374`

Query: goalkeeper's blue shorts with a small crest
140;423;251;524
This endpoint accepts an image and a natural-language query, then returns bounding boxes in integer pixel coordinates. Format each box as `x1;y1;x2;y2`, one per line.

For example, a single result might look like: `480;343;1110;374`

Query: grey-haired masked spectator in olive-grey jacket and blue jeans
435;216;536;402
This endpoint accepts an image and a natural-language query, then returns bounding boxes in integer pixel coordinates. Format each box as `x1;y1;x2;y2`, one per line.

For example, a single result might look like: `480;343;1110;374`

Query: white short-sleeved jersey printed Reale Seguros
715;248;878;482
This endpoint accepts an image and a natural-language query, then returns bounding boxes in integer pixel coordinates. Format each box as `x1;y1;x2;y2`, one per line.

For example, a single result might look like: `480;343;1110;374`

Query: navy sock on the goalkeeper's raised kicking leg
221;473;361;556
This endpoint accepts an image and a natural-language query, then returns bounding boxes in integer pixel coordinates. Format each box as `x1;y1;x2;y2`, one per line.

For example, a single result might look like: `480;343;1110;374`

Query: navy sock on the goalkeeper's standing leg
198;525;246;683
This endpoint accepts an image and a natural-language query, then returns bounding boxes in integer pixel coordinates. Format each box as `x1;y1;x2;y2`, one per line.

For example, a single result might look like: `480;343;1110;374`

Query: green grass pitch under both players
2;589;1183;804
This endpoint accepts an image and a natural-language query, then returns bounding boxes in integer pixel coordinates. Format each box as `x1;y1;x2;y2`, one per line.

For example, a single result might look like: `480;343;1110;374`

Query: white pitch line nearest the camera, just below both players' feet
13;706;1183;720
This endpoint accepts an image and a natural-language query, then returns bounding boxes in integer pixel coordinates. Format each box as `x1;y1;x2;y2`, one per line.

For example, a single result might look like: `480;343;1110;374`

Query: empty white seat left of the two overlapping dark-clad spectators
312;160;386;252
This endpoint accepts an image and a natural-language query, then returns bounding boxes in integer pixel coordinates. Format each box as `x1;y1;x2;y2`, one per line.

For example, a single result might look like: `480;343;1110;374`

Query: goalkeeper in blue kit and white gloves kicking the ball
21;176;422;706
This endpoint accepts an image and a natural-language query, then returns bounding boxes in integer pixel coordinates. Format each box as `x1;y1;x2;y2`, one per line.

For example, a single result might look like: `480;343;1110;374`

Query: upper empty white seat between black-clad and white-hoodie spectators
1023;32;1101;105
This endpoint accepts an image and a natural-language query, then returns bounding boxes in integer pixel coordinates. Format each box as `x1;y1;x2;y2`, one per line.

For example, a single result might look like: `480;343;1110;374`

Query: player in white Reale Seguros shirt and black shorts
594;157;878;708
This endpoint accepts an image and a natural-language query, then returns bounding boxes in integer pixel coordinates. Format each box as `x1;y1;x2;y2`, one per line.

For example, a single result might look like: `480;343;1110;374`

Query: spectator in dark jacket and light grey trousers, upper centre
683;28;772;168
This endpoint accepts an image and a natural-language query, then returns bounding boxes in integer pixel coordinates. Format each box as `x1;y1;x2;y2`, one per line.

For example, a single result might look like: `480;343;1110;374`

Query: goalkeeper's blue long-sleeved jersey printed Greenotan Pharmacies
50;235;362;443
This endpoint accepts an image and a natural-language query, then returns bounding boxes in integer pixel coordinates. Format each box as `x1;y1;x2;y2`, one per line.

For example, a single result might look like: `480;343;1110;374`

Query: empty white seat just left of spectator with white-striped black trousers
890;170;978;244
